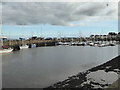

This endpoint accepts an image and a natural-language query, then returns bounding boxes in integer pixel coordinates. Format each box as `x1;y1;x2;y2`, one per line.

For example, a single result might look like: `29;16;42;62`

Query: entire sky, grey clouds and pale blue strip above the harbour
0;2;118;38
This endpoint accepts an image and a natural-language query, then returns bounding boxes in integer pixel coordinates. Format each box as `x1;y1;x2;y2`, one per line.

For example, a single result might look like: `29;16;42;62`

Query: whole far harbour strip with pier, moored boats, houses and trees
0;32;120;53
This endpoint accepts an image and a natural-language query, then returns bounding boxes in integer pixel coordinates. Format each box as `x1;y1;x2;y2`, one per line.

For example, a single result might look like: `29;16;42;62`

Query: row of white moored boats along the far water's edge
0;41;119;53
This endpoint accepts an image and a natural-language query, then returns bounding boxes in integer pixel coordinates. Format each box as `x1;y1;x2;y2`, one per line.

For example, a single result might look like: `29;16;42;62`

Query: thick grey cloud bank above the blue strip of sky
0;2;117;26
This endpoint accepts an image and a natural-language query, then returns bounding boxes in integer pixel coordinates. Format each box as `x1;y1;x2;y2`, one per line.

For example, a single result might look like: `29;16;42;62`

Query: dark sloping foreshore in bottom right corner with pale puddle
45;55;120;90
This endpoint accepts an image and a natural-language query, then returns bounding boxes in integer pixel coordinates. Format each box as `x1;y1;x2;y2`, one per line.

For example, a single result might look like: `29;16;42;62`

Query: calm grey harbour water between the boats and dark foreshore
2;46;118;88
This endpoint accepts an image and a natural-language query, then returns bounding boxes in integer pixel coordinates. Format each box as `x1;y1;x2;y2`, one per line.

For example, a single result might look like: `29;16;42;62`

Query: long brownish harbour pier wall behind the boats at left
3;40;57;51
